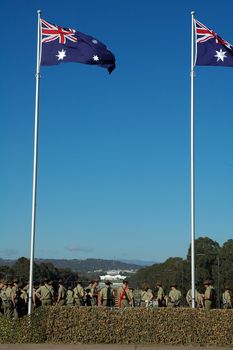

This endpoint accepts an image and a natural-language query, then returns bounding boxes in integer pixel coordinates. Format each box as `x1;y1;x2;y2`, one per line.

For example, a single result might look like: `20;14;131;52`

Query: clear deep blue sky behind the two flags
0;0;233;261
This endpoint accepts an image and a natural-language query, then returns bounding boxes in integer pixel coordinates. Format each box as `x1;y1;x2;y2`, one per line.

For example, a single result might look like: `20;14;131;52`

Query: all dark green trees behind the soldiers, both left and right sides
0;237;233;295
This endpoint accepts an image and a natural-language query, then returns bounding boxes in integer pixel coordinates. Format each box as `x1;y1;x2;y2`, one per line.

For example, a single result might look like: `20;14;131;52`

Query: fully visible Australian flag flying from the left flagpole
41;19;115;73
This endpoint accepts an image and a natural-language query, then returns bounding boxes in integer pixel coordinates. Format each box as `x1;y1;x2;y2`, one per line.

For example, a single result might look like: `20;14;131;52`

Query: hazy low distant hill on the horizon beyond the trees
0;259;141;273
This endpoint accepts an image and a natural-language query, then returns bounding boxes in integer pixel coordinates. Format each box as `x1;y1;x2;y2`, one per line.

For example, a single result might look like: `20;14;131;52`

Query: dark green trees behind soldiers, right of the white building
130;237;233;295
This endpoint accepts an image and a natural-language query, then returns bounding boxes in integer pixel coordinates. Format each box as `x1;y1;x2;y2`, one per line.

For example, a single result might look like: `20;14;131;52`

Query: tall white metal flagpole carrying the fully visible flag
28;10;41;315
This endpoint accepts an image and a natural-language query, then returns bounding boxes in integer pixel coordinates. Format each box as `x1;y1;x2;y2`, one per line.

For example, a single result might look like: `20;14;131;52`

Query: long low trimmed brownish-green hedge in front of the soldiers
0;306;233;346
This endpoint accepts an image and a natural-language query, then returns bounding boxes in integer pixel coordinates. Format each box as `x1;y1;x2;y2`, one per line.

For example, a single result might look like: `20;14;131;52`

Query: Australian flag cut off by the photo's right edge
194;19;233;67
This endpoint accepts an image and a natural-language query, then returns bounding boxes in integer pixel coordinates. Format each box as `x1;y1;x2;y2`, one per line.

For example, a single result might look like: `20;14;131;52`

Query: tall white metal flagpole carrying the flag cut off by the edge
190;11;195;308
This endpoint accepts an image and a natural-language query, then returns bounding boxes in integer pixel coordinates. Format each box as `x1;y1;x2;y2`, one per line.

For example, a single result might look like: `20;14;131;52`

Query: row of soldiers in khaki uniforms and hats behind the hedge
0;280;232;318
